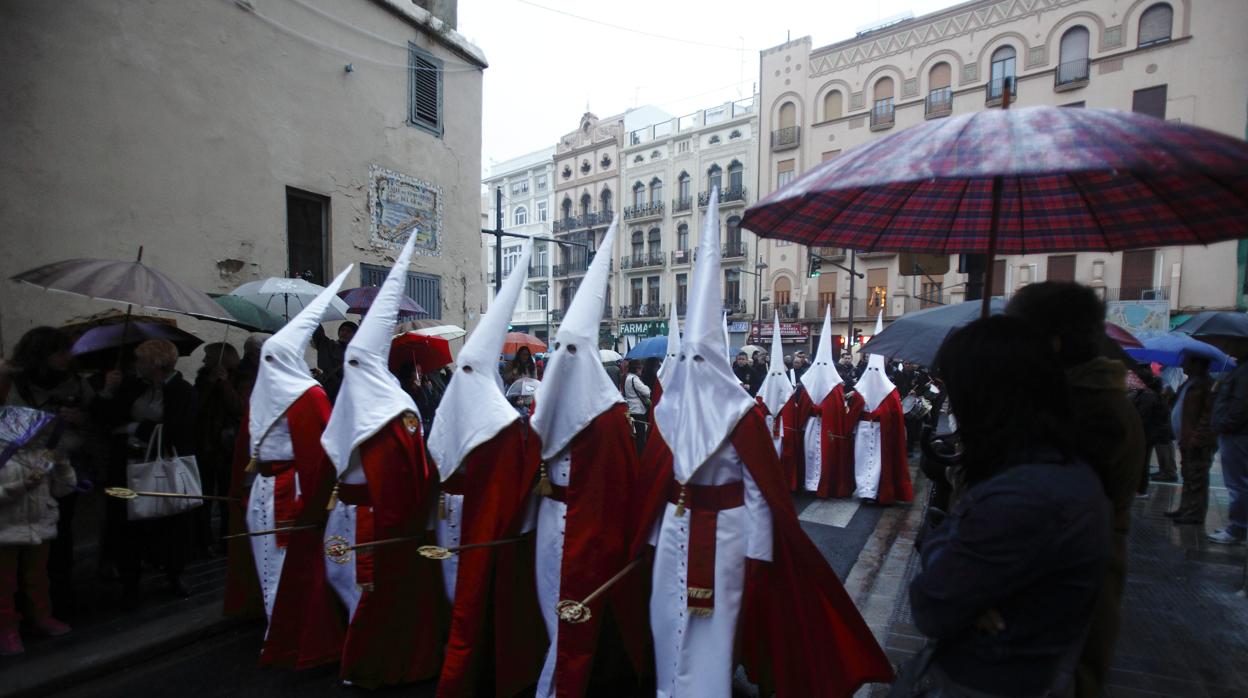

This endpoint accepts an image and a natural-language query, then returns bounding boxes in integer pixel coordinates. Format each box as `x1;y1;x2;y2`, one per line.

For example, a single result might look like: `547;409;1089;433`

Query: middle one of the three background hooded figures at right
796;306;856;497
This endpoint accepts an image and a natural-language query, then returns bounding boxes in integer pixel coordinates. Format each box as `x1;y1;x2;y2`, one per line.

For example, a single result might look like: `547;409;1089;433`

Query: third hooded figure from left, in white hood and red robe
424;243;545;697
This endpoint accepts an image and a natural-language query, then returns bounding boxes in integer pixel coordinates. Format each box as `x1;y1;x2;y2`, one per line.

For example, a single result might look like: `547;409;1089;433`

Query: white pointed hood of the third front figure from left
429;241;533;479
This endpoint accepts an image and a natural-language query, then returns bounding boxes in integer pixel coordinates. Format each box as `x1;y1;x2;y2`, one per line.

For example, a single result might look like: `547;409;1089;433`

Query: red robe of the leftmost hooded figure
260;386;346;669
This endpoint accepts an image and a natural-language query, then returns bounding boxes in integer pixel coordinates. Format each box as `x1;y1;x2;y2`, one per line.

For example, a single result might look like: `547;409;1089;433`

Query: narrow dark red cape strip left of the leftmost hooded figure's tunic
222;412;265;619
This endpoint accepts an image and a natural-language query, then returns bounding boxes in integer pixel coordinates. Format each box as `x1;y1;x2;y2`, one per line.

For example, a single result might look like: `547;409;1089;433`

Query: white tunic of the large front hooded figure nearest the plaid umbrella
650;443;771;697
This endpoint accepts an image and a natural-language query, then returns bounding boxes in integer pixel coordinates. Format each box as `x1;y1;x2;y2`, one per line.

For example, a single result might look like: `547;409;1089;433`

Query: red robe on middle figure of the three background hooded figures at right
794;385;861;498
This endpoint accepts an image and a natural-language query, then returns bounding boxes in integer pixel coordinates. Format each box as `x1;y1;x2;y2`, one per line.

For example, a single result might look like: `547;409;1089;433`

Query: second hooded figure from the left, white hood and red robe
321;233;442;687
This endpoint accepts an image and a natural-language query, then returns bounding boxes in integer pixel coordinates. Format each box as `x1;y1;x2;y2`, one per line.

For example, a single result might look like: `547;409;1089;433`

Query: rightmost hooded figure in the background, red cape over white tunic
849;310;915;504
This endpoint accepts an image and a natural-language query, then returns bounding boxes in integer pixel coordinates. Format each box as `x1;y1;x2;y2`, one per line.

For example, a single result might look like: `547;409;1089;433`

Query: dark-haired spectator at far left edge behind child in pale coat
0;327;95;618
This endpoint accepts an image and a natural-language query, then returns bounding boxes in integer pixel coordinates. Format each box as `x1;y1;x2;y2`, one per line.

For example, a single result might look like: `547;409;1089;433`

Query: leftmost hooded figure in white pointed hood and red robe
246;266;352;669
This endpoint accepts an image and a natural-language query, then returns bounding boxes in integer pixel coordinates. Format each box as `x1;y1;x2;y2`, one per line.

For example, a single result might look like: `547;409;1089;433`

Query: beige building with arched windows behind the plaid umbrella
759;0;1248;352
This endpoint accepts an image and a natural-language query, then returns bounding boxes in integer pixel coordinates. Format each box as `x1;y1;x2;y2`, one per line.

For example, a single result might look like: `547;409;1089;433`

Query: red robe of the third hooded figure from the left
439;421;547;697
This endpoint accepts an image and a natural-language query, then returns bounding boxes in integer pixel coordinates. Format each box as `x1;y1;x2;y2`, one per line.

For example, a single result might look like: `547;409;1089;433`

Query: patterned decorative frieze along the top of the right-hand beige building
807;0;1085;77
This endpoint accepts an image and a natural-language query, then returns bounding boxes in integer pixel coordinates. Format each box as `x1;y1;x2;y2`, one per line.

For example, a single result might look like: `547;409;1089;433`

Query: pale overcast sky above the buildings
459;0;956;171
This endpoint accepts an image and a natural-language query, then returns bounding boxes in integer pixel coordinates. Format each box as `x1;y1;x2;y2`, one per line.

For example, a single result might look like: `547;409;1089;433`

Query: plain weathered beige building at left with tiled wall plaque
0;0;485;347
